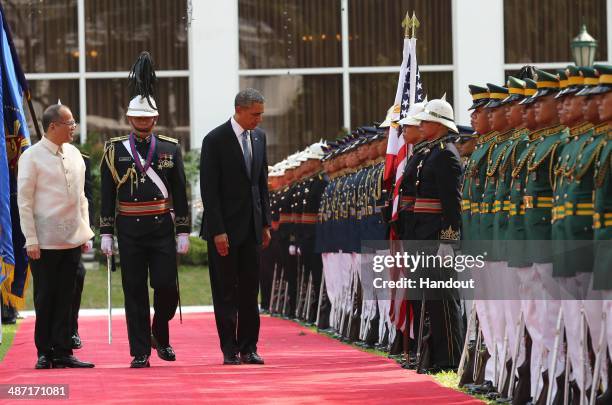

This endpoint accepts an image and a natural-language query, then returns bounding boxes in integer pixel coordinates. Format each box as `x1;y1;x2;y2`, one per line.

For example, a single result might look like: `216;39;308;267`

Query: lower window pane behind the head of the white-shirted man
24;80;81;141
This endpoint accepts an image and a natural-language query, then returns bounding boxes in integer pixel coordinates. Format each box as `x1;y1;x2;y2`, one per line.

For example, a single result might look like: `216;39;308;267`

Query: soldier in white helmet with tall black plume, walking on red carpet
100;52;190;368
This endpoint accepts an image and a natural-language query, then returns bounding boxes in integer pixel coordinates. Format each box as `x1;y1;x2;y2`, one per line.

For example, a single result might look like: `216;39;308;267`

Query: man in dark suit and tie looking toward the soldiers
200;89;271;365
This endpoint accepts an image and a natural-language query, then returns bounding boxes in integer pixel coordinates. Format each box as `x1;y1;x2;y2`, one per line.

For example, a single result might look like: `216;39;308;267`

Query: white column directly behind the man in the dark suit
189;0;239;149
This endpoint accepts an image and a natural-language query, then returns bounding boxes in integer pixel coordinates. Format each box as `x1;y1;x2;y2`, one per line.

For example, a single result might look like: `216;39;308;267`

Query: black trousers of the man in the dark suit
208;235;261;355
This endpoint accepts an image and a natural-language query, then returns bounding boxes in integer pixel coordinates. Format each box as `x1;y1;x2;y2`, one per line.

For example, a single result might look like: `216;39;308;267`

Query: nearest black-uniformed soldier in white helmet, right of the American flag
407;99;464;372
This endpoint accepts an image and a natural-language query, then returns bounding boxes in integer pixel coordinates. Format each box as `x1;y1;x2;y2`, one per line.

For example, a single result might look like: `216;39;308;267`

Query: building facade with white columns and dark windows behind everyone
9;0;612;162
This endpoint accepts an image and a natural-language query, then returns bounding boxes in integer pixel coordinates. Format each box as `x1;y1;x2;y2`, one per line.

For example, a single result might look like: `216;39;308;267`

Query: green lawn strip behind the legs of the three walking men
24;265;212;310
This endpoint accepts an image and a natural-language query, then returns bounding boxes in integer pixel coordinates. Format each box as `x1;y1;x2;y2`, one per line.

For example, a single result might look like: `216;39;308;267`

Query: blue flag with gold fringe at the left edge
0;4;30;309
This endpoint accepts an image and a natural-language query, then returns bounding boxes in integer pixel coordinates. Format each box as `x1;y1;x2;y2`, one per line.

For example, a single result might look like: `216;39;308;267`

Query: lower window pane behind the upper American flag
351;72;453;128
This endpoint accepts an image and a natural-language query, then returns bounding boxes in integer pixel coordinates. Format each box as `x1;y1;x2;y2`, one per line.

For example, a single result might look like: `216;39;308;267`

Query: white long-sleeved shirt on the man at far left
17;137;94;249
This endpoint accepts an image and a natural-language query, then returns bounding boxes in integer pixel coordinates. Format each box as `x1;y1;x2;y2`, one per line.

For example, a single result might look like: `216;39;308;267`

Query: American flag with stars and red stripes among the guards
384;38;425;336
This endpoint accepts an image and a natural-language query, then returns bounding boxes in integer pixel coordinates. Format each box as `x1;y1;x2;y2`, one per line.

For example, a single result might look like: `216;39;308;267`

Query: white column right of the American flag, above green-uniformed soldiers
452;0;504;124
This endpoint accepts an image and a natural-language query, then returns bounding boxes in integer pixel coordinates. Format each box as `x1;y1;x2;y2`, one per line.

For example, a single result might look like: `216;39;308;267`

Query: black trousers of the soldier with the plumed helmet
117;216;178;356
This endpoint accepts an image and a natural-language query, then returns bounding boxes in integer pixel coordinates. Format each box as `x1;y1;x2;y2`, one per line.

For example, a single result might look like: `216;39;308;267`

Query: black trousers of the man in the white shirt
30;247;81;357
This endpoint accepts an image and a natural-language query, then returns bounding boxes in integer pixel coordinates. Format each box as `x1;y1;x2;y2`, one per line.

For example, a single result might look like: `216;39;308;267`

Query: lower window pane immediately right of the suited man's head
240;75;342;163
